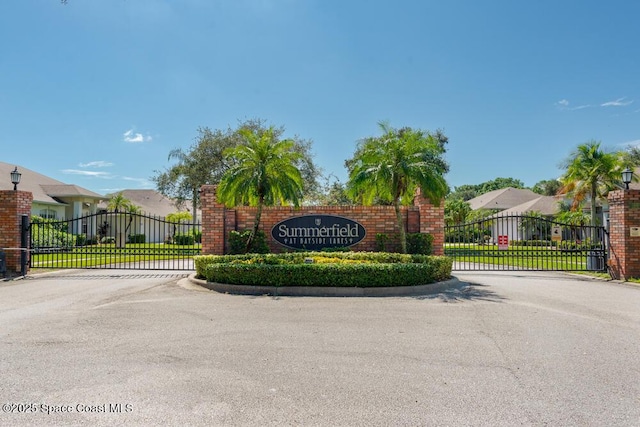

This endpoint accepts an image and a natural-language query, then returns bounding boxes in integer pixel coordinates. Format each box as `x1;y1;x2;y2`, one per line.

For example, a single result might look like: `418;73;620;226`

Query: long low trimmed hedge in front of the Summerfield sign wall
195;252;452;287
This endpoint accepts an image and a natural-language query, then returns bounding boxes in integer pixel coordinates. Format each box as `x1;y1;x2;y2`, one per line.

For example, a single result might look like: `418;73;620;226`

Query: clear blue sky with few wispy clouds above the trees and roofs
0;0;640;194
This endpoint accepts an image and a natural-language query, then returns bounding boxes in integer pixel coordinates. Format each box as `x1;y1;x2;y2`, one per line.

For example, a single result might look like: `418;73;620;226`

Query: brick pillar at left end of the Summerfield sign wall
200;185;225;255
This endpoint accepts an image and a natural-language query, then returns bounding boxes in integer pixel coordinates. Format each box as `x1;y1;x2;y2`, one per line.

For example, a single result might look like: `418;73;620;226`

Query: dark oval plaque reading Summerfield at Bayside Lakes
271;215;366;251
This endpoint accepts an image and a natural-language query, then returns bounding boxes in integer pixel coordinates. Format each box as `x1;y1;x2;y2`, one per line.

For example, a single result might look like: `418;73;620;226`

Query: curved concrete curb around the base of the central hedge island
188;273;461;297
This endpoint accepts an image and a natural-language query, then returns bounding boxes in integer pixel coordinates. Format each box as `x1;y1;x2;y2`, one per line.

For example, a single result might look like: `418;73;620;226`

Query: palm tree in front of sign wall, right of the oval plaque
346;123;449;253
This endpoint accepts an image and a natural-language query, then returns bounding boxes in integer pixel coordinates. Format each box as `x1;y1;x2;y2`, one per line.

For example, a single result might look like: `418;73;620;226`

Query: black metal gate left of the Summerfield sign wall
29;212;202;270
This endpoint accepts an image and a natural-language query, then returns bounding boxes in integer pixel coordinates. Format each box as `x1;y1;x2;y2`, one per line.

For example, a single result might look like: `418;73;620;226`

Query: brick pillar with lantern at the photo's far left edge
0;190;33;275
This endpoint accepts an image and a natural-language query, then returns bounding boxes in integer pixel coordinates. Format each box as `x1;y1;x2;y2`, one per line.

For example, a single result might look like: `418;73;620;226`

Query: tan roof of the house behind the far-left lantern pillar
0;162;104;205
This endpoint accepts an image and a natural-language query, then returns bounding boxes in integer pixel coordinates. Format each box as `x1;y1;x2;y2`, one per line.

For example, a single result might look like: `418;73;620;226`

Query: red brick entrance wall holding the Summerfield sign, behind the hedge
200;185;444;255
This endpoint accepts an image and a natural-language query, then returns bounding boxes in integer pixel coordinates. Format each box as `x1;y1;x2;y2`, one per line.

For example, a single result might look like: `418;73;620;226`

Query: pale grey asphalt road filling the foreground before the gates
0;270;640;426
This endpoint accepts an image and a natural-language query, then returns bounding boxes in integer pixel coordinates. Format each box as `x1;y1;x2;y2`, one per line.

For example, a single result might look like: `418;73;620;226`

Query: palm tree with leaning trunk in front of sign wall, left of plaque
218;127;303;252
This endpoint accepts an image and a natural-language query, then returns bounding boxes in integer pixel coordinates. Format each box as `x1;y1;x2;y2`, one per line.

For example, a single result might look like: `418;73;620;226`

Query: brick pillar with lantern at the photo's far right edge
608;190;640;280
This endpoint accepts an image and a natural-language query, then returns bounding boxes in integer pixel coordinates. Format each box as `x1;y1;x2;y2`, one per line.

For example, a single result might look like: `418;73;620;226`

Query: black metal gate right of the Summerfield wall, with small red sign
444;214;608;271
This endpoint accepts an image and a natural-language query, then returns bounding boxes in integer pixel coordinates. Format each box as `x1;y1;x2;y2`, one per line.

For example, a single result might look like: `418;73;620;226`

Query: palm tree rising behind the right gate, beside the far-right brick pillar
559;140;622;226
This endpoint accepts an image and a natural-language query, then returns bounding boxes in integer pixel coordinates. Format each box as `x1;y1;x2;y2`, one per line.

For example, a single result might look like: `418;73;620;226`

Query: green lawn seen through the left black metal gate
31;243;201;268
